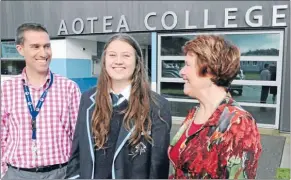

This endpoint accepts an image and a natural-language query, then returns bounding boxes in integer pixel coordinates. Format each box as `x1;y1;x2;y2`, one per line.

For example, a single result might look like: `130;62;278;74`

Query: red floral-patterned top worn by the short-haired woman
168;98;262;179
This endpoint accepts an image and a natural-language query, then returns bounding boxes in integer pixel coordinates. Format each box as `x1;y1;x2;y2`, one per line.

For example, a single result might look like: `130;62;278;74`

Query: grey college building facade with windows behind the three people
1;1;290;132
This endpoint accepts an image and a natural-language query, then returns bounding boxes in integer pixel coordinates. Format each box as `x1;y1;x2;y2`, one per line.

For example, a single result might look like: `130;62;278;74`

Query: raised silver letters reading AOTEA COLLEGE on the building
58;5;288;35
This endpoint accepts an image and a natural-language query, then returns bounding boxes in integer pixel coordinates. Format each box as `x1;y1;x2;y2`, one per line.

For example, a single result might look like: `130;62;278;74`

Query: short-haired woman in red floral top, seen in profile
168;35;261;179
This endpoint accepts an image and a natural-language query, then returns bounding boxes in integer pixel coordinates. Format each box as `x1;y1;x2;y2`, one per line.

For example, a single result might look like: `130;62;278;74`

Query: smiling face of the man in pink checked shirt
16;30;52;73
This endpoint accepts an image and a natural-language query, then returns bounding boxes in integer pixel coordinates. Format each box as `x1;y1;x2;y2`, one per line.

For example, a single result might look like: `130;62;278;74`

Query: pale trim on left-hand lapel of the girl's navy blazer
86;93;96;179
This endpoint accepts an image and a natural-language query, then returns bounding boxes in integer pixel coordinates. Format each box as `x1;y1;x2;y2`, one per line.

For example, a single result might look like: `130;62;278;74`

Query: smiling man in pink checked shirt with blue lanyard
1;23;81;179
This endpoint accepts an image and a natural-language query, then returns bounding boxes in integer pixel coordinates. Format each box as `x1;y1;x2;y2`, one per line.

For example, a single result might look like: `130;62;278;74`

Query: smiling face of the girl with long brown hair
105;40;136;83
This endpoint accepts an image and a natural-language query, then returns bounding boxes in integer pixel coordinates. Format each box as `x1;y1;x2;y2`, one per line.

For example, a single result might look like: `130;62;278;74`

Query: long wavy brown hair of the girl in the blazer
92;33;152;149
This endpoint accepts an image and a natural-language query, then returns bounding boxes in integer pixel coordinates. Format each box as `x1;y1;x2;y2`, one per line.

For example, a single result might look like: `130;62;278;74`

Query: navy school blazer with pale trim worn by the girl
66;87;172;179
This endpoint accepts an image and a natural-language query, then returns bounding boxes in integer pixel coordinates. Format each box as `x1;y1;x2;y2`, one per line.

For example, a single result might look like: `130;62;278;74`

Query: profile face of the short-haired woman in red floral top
180;53;212;98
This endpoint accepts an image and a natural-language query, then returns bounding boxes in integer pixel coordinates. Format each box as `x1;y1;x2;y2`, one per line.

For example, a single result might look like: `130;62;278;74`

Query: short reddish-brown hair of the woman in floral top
183;35;240;87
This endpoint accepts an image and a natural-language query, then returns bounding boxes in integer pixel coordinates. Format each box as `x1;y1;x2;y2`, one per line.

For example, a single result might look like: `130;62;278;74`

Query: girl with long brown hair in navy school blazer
67;34;171;179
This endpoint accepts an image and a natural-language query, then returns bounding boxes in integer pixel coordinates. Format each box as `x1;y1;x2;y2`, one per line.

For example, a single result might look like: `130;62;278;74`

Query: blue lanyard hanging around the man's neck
23;72;53;140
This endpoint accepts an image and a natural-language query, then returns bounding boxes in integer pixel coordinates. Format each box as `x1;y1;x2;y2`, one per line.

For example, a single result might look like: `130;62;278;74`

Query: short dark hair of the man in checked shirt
15;23;48;45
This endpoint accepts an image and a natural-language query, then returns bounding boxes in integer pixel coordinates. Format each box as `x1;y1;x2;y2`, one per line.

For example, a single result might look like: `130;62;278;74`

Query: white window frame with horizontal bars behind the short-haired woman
157;30;284;129
